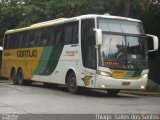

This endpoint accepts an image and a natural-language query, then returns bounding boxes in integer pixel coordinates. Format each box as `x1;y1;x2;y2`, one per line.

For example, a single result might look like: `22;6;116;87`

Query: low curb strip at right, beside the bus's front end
121;91;160;97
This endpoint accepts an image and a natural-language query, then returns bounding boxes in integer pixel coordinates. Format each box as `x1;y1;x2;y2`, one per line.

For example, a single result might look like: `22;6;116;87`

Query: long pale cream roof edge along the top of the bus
5;14;141;34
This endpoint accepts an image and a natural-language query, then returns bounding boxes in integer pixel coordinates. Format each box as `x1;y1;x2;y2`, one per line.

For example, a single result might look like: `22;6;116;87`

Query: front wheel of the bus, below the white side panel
67;72;78;94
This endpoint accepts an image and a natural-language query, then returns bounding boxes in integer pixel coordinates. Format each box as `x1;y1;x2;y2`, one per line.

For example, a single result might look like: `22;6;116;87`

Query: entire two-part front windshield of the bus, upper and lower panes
98;18;147;69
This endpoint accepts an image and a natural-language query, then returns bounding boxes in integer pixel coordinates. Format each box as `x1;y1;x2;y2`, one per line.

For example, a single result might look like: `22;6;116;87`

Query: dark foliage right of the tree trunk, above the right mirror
131;0;160;36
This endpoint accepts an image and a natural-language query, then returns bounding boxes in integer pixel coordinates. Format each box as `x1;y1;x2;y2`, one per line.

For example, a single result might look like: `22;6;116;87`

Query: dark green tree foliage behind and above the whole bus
0;0;160;45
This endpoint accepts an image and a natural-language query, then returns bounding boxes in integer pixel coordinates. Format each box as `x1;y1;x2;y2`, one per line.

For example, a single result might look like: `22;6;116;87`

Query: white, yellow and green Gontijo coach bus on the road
2;15;158;95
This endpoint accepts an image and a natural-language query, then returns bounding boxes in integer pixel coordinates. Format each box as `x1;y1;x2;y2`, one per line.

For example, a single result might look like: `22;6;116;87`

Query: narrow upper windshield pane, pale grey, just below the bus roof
98;18;144;35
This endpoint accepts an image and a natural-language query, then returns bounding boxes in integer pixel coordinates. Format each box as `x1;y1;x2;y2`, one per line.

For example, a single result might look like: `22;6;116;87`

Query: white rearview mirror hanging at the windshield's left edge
94;29;102;45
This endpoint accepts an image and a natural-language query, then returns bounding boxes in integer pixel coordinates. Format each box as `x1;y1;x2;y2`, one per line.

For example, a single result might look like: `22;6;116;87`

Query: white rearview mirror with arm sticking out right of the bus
146;34;158;52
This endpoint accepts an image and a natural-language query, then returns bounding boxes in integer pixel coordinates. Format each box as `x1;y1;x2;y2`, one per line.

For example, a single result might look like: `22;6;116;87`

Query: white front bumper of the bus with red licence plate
95;75;148;90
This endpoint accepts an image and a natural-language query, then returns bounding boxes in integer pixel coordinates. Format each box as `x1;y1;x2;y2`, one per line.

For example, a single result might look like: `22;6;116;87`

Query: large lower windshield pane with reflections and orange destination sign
99;34;146;69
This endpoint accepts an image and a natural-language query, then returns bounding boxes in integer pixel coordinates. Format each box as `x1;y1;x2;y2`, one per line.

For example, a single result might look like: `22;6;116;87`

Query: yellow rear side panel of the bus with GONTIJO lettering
2;48;43;79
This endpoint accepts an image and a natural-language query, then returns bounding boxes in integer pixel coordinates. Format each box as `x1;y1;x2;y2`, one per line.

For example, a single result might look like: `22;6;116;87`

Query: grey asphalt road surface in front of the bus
0;83;160;114
